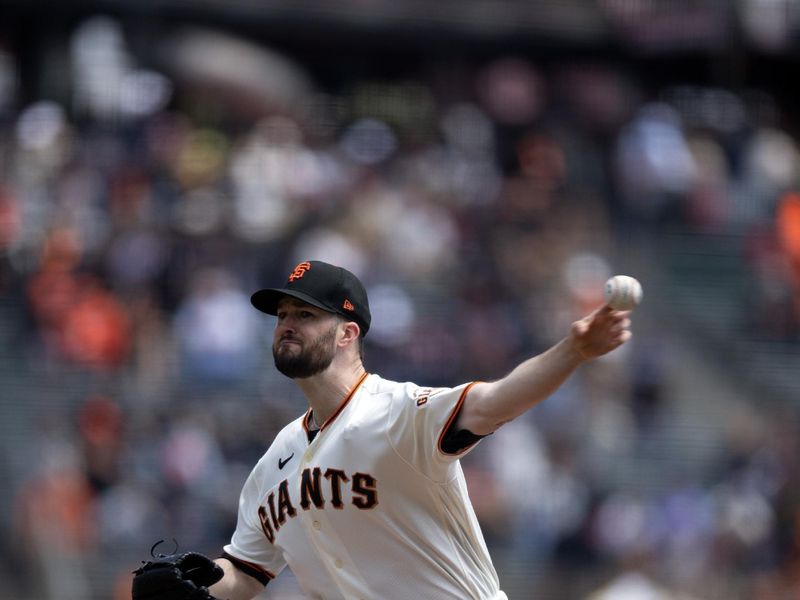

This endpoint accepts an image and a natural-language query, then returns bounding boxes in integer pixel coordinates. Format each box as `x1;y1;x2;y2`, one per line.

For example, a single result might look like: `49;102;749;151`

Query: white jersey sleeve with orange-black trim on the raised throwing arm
388;383;479;480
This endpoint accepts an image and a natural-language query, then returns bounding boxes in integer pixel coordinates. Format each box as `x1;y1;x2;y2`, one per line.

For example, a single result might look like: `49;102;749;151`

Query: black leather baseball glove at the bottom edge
132;542;223;600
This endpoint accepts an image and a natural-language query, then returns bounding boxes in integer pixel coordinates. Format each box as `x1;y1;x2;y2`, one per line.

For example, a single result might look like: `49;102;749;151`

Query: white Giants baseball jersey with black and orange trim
225;375;506;600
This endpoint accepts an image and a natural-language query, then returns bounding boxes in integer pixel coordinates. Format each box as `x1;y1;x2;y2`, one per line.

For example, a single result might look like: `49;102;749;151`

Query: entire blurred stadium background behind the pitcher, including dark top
0;0;800;600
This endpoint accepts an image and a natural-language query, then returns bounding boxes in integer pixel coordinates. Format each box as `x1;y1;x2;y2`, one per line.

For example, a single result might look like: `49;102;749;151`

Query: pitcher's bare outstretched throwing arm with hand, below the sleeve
455;305;631;436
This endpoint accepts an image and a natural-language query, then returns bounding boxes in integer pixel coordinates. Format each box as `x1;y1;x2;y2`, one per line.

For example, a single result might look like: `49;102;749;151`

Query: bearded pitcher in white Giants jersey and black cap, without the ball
133;261;631;600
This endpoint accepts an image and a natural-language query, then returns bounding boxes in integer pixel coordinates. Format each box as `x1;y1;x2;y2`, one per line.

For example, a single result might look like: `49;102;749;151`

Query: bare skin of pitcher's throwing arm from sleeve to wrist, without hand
458;338;585;435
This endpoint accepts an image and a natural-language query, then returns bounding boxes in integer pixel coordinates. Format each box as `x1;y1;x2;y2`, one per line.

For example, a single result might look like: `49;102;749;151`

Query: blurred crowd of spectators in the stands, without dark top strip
0;17;800;600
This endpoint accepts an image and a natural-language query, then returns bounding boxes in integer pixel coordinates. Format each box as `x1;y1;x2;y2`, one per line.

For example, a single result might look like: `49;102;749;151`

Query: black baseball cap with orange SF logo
250;260;372;336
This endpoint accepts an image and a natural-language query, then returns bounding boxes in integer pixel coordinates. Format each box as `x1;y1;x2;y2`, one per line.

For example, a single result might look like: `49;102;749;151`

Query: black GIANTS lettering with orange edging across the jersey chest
258;467;378;544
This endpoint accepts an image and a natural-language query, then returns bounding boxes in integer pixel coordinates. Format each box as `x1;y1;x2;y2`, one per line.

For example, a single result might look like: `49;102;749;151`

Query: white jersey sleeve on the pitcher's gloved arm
223;462;286;579
